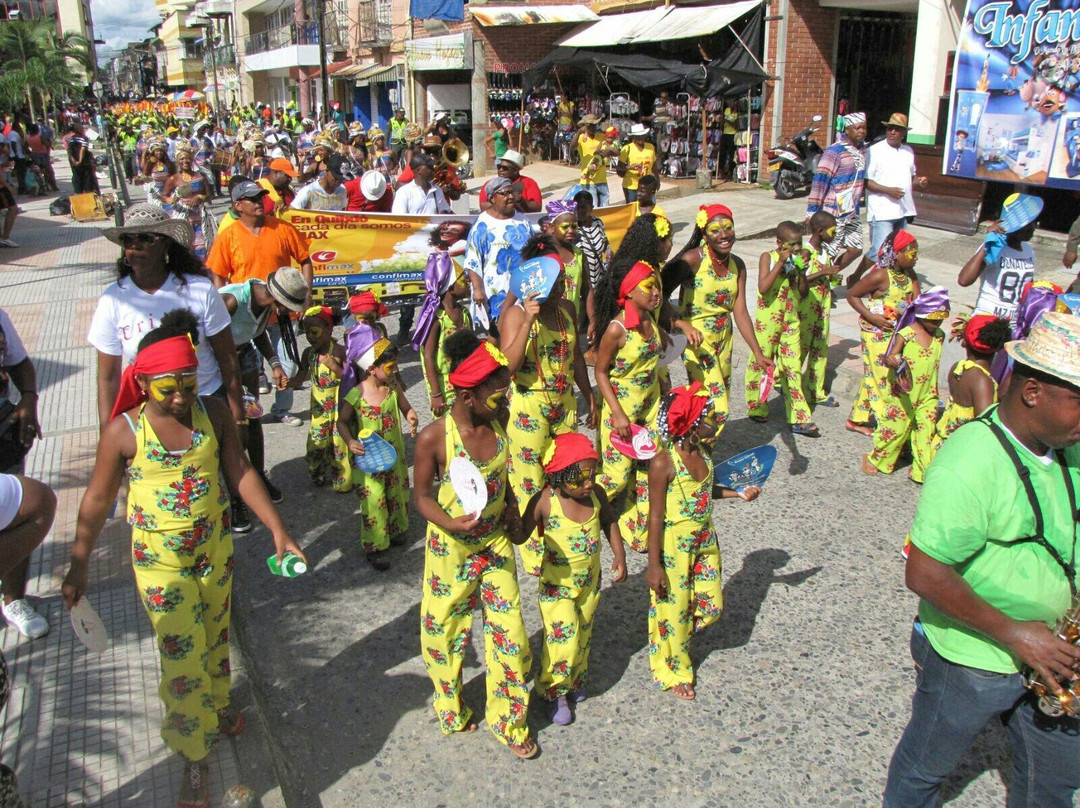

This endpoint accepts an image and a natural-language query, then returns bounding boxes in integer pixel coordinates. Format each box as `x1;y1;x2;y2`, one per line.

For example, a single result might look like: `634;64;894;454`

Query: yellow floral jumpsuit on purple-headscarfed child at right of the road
869;326;945;483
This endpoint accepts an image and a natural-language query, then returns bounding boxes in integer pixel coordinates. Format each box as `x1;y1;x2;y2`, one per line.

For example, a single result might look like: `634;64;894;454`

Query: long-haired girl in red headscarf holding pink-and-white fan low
595;214;672;553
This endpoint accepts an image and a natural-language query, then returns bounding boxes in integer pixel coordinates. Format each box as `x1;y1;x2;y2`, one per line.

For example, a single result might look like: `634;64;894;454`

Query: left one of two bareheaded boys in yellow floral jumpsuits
746;221;821;437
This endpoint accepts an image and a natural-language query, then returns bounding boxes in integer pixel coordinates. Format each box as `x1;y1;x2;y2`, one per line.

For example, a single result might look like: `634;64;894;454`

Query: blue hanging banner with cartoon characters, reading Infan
942;0;1080;189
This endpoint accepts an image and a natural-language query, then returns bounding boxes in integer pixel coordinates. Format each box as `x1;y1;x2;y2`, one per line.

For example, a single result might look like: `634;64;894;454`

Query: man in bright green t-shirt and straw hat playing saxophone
883;312;1080;808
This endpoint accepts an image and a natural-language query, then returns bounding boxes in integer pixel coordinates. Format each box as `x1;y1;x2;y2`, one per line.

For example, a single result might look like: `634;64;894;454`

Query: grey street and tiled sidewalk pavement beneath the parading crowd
0;159;1070;808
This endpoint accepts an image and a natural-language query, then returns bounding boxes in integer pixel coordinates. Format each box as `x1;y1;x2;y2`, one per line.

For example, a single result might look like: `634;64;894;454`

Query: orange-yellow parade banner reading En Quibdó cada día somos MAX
282;205;634;304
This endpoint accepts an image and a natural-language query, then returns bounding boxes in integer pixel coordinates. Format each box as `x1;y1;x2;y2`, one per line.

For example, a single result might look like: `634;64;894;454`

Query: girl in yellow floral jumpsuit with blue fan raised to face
500;264;597;575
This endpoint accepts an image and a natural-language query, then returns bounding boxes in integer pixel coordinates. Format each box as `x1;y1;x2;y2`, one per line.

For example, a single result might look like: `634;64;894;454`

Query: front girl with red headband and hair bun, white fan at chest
414;331;540;758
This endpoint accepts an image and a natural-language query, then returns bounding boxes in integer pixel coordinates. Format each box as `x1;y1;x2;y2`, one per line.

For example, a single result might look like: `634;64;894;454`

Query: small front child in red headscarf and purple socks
522;432;626;726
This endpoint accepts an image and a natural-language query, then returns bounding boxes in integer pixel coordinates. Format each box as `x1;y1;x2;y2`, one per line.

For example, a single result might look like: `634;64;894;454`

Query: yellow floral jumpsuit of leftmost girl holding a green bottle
124;401;232;760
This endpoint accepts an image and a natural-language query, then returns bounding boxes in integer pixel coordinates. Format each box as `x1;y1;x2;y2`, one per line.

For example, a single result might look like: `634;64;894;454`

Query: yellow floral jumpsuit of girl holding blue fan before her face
507;308;578;575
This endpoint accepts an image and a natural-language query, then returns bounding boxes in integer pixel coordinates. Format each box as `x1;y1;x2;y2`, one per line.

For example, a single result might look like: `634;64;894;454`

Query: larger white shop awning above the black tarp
558;0;762;48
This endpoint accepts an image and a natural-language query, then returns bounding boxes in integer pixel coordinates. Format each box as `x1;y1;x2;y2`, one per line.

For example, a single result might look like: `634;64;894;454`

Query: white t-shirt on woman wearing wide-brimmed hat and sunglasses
86;274;230;395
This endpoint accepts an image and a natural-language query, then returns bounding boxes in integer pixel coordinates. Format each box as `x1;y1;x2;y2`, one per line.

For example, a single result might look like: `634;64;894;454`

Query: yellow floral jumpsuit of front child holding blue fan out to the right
649;448;724;690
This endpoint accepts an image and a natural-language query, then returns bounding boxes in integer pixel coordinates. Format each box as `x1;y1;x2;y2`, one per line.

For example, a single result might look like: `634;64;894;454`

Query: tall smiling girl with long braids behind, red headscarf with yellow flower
661;205;772;442
